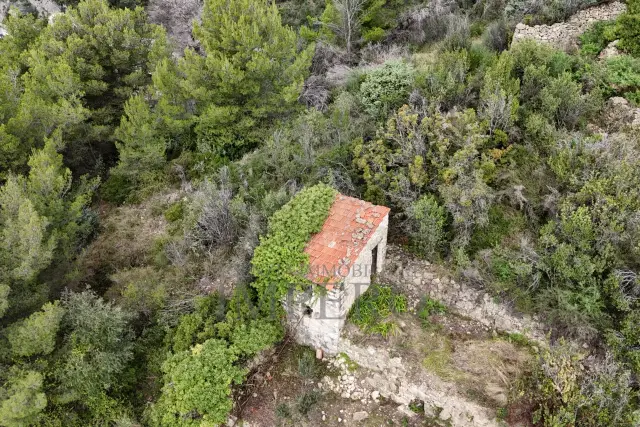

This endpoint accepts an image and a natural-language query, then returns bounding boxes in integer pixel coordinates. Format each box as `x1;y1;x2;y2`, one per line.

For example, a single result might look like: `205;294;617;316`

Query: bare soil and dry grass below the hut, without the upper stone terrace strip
236;302;531;427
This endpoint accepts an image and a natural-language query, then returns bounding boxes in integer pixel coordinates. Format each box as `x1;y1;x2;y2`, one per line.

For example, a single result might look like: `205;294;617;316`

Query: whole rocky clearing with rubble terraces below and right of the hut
234;246;544;427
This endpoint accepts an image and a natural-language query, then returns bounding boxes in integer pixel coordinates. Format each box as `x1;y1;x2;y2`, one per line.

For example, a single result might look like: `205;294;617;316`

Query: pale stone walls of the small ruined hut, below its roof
284;215;389;354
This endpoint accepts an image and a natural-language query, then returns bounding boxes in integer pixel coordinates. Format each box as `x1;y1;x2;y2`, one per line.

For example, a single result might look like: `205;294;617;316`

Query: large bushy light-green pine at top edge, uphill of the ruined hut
115;0;313;181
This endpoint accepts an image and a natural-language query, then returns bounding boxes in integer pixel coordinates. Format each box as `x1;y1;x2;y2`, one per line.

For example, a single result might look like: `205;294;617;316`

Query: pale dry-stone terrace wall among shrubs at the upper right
513;1;626;49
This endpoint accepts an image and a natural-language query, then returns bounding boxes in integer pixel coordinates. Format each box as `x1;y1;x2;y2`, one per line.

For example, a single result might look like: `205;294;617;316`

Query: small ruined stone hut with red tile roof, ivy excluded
285;194;389;354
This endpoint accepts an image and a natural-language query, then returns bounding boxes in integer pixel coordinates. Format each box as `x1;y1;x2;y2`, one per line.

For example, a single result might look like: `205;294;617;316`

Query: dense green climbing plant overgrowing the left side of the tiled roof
251;184;336;313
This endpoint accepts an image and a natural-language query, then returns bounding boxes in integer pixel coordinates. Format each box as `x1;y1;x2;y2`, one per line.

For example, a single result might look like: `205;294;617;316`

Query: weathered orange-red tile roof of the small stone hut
304;194;389;289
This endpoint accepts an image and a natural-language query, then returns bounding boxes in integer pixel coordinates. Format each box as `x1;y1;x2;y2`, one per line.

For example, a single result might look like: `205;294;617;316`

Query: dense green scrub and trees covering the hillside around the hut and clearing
0;0;640;427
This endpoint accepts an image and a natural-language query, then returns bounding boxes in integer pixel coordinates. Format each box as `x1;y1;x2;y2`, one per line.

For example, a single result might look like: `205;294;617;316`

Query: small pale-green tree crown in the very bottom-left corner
0;369;47;427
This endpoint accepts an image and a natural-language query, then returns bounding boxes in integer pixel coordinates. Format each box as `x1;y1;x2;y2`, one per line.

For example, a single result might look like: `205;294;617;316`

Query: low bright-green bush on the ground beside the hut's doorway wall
349;284;407;337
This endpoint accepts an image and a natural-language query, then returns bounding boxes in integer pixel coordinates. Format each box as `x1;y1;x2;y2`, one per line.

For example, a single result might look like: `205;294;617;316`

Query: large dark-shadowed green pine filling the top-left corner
0;0;168;172
